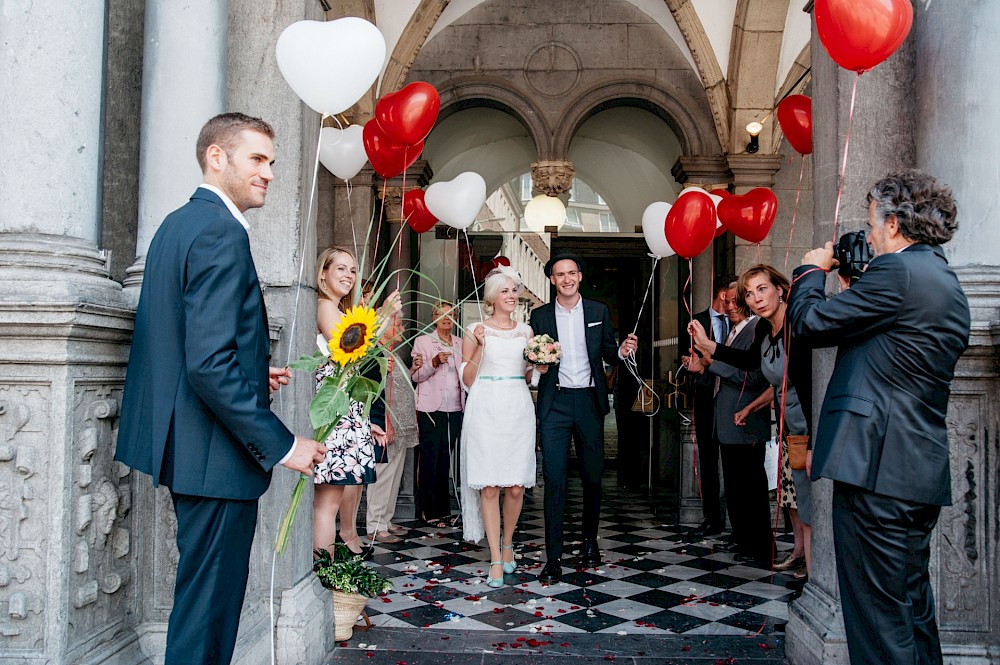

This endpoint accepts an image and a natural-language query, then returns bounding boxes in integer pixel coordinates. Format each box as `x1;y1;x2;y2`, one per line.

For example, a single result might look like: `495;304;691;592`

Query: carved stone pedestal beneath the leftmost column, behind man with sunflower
0;233;141;664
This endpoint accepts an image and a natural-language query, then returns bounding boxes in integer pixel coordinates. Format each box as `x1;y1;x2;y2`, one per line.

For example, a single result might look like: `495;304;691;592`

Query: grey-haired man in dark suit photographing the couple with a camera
789;171;969;665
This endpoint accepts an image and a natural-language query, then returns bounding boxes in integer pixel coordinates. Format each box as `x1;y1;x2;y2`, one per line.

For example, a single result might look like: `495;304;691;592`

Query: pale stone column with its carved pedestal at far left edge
0;0;141;665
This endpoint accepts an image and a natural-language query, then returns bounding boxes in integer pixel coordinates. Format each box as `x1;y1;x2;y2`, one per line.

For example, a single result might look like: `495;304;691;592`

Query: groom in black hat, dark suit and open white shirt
530;254;638;584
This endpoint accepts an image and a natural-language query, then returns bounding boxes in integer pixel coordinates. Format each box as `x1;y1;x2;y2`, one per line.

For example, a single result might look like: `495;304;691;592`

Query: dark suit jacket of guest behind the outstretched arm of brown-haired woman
705;319;771;444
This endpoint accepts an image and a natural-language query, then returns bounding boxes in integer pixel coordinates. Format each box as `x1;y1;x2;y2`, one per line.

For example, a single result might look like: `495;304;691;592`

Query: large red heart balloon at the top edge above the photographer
813;0;913;74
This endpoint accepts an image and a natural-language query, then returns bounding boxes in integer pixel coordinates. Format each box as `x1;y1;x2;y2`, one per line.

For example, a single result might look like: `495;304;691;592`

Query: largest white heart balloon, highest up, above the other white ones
274;16;385;115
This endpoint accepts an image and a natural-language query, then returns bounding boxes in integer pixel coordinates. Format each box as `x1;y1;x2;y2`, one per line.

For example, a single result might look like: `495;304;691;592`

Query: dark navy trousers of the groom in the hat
540;388;604;561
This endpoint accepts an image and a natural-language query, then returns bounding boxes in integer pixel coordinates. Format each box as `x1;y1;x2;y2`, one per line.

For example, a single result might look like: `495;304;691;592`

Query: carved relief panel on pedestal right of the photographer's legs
933;392;990;631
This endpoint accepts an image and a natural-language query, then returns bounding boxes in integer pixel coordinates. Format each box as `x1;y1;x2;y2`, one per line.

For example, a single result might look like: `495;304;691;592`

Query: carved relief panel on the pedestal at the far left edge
0;381;51;653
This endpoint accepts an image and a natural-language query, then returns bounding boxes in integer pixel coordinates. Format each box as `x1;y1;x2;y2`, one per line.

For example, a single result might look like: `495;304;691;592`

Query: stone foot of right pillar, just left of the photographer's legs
785;584;850;665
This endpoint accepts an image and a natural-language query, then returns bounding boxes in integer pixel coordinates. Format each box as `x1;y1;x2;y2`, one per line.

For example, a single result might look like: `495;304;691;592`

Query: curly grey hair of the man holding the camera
868;169;958;245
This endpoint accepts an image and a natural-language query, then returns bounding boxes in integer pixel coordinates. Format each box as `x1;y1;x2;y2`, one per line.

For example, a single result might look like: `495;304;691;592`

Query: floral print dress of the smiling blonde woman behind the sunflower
313;363;376;485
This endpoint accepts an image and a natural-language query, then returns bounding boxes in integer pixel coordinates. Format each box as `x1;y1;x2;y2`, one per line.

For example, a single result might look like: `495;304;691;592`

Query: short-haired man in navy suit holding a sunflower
115;113;325;665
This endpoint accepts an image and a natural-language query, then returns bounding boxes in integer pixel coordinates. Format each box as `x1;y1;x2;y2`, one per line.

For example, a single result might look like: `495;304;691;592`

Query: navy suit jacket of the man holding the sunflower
115;188;294;499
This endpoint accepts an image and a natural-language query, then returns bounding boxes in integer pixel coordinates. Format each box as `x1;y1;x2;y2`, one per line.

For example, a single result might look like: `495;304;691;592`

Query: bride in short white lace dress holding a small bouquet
461;266;548;588
